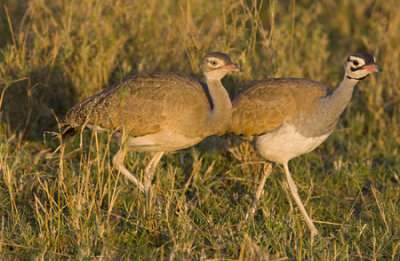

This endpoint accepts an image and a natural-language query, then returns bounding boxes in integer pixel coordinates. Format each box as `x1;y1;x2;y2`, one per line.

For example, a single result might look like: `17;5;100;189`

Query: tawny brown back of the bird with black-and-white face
231;78;331;136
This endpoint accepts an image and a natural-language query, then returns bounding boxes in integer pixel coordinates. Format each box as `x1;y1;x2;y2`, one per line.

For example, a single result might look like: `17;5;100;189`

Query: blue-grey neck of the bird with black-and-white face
314;76;358;130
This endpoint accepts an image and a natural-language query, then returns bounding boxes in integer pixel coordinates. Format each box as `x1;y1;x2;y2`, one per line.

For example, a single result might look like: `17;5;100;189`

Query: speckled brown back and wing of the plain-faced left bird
63;73;212;137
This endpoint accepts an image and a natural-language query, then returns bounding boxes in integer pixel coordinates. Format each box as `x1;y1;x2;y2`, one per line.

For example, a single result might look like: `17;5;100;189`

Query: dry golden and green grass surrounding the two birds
0;0;400;260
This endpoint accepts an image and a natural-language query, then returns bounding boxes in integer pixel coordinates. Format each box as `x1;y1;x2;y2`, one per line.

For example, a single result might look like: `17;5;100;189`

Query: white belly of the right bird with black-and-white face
255;124;330;163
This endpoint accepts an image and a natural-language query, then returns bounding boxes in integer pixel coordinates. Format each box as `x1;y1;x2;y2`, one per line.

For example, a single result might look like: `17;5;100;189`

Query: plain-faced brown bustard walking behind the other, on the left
60;52;241;194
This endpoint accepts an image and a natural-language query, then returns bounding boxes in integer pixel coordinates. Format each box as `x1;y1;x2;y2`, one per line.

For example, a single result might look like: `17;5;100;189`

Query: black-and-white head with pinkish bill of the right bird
344;52;382;80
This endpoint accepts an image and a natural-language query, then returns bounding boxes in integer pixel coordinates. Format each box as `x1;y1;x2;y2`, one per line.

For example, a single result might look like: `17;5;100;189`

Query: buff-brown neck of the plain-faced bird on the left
206;79;232;134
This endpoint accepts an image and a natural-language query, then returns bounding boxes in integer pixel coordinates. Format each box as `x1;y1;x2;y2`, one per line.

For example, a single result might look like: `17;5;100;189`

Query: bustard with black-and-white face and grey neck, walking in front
230;52;382;239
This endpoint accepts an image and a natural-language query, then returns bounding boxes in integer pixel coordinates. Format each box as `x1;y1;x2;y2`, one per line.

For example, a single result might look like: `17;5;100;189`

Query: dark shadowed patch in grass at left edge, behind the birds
0;63;76;140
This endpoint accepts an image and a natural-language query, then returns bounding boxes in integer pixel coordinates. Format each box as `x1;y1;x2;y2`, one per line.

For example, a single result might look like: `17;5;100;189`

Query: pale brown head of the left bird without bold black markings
200;52;242;80
